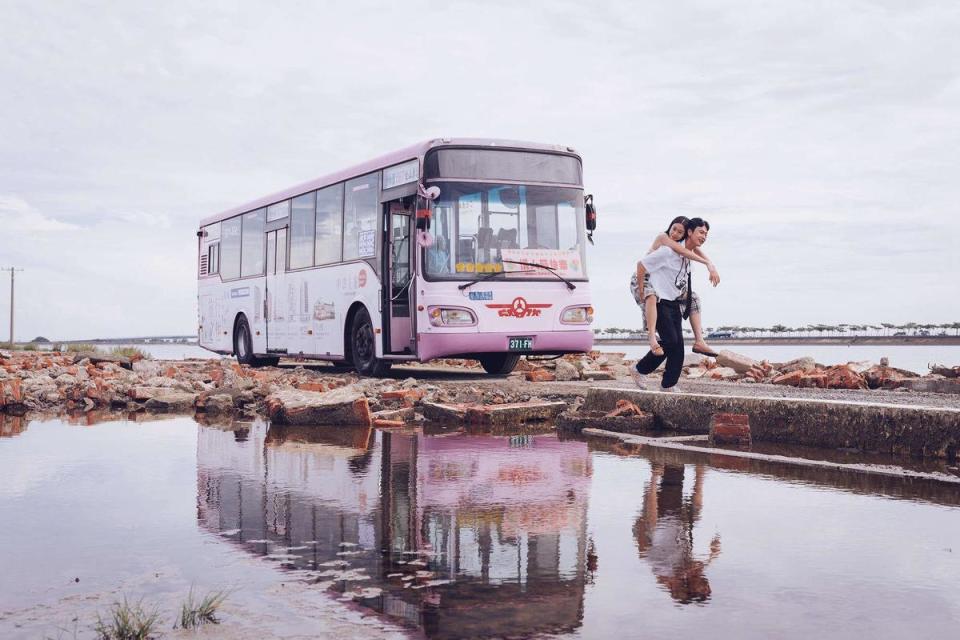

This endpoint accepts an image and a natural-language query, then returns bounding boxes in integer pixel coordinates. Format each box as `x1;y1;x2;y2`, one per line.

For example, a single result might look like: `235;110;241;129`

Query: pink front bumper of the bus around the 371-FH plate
417;330;593;362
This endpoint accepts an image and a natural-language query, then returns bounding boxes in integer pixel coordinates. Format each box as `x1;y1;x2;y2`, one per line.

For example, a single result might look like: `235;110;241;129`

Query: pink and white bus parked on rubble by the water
197;138;595;375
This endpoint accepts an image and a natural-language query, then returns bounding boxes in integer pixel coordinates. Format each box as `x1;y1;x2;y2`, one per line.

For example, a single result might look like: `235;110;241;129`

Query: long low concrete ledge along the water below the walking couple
581;387;960;459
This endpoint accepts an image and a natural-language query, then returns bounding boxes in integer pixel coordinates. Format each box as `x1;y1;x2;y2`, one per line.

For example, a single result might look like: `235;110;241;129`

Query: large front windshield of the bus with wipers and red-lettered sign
424;182;586;280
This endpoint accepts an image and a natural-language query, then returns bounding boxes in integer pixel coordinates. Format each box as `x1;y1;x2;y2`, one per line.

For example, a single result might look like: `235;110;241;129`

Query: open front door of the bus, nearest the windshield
383;196;416;355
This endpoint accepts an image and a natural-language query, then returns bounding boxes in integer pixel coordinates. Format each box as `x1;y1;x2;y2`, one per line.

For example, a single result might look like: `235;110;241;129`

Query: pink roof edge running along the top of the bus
200;138;579;227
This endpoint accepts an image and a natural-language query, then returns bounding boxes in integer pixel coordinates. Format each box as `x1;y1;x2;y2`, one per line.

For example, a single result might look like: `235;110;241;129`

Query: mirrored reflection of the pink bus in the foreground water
198;422;591;638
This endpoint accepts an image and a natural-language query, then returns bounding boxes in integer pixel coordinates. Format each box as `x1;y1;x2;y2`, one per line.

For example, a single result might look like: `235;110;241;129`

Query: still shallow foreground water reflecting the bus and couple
0;418;960;638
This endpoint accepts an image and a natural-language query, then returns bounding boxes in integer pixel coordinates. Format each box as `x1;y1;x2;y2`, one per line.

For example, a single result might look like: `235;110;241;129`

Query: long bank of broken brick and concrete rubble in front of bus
0;351;563;427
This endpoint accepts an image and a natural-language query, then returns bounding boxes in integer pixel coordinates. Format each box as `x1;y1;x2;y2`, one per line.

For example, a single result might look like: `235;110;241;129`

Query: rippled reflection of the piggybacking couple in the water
633;463;720;604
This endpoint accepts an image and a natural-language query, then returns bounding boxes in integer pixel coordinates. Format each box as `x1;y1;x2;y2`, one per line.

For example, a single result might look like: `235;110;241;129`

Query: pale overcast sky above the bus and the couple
0;0;960;340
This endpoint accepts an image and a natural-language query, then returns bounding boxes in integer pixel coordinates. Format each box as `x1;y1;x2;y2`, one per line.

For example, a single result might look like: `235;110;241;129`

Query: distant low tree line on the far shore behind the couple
593;322;960;338
